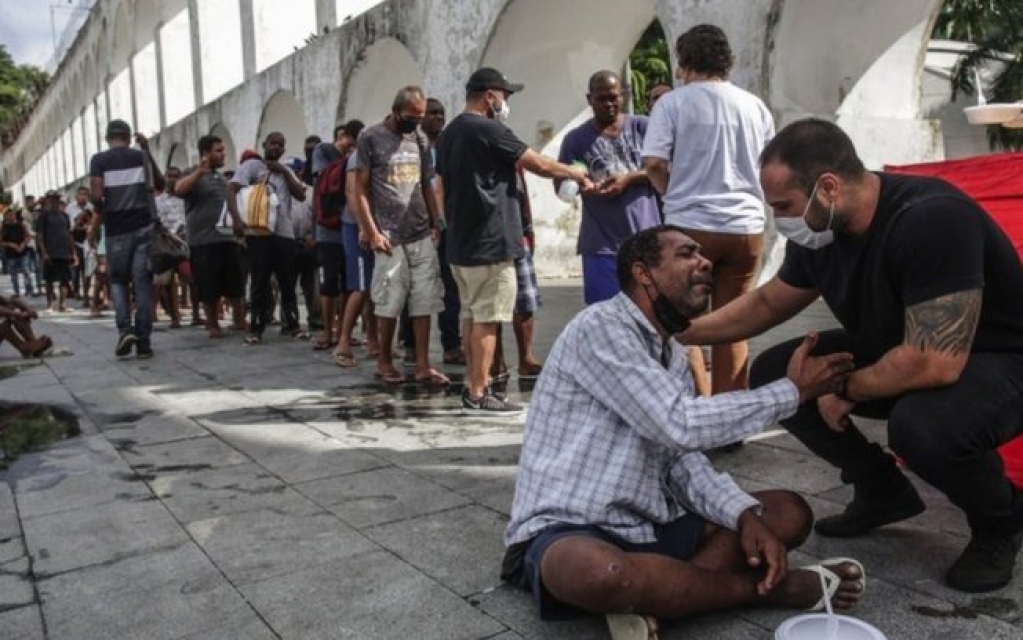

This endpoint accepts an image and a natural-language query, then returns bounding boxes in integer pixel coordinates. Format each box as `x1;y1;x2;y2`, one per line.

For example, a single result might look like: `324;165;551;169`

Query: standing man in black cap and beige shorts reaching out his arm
437;67;592;414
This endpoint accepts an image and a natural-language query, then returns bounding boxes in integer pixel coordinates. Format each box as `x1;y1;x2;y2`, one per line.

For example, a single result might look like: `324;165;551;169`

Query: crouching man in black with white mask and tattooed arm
683;120;1023;592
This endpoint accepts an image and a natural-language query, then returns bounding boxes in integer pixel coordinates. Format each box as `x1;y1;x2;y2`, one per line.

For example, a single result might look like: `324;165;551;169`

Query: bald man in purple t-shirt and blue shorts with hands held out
554;71;661;305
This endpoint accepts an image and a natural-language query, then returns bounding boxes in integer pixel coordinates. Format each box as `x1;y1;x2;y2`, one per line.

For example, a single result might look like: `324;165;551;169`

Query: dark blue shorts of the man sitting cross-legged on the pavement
501;513;707;621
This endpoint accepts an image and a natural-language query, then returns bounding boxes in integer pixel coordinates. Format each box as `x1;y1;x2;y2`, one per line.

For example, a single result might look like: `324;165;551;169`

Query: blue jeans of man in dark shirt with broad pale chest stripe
106;225;152;347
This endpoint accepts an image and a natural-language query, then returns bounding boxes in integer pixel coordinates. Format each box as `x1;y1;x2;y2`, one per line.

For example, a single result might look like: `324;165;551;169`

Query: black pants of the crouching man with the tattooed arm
750;330;1023;533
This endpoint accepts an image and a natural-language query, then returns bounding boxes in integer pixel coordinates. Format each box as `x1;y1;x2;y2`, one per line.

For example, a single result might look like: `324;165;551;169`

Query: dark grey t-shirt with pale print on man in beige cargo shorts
356;123;434;244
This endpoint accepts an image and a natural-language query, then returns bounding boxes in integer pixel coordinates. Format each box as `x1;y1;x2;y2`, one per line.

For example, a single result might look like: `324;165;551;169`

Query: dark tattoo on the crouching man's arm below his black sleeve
905;289;982;356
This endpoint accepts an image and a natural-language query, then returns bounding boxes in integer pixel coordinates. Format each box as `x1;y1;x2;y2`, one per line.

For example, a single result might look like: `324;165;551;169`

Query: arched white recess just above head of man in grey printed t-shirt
338;37;422;125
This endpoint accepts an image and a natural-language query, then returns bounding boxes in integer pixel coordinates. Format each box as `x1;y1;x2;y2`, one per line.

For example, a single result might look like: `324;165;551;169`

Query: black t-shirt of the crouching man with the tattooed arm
779;174;1023;364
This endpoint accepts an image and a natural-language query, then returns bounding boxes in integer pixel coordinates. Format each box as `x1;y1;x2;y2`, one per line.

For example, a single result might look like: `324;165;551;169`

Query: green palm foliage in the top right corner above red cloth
934;0;1023;151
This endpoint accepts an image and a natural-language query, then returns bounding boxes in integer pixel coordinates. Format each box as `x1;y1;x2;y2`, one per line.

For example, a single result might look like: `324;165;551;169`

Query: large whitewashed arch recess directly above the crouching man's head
768;0;943;168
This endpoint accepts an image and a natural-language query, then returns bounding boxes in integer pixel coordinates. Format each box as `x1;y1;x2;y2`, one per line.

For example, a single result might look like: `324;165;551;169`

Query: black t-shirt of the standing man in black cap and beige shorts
437;113;528;267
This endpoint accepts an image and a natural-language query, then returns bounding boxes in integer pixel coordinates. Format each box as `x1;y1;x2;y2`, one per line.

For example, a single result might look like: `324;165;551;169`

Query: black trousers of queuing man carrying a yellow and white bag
246;235;299;335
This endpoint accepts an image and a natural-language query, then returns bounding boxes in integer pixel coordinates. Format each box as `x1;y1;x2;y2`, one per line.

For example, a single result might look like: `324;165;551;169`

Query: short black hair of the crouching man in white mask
760;118;866;192
